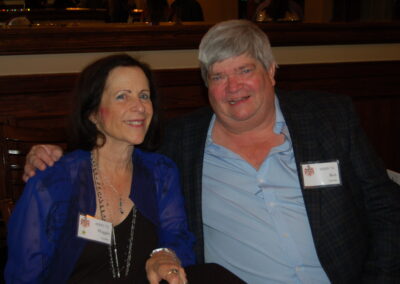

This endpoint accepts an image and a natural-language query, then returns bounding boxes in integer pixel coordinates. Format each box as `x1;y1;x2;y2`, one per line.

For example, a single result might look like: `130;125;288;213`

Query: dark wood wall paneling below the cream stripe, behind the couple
0;61;400;171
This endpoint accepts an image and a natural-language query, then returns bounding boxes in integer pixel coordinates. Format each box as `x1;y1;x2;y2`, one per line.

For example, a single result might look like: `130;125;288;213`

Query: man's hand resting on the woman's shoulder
22;145;63;182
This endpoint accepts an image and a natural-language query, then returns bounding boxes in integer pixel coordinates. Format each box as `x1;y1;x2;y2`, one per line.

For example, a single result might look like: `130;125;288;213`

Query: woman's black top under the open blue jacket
69;211;157;284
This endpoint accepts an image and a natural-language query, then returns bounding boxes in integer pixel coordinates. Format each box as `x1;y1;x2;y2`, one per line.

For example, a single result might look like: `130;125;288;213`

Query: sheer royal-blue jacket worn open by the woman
5;149;195;283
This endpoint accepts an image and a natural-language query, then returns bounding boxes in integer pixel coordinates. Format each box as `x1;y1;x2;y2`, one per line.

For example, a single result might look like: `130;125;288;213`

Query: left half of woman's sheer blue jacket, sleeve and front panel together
5;151;91;283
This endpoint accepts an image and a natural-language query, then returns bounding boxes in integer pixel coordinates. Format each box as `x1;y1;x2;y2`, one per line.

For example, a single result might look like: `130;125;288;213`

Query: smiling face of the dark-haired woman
92;66;153;148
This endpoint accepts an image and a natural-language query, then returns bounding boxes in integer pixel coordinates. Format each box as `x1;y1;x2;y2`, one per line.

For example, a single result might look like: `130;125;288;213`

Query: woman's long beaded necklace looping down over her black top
90;151;136;279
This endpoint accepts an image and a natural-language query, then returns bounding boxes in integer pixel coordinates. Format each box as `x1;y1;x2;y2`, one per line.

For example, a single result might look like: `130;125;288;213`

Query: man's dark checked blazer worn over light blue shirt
160;92;400;284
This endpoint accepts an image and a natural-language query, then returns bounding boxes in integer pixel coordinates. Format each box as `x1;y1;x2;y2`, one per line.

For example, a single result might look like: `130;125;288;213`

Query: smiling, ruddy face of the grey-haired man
208;54;275;130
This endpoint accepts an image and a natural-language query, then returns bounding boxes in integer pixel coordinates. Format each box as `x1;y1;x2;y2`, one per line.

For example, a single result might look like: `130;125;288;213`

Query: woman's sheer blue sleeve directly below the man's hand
5;165;70;283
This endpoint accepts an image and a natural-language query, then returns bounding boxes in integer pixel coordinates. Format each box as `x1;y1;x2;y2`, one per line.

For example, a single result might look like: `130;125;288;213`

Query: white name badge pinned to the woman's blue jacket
78;214;112;245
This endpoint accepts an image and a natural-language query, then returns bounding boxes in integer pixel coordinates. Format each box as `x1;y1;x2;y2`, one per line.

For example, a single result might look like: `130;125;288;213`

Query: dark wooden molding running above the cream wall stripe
0;22;400;55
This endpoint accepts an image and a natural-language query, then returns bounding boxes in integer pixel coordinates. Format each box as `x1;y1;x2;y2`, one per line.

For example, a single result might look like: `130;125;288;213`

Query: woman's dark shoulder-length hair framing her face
68;54;160;151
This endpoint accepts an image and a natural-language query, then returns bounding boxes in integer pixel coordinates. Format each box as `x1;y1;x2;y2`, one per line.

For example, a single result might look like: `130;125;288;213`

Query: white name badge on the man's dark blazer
301;160;342;189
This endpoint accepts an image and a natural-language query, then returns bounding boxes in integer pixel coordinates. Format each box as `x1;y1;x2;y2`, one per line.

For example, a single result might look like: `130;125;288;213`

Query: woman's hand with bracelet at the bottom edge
146;251;187;284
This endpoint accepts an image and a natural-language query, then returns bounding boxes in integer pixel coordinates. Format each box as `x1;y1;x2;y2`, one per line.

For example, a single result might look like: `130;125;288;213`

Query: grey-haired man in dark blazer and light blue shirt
22;20;400;284
